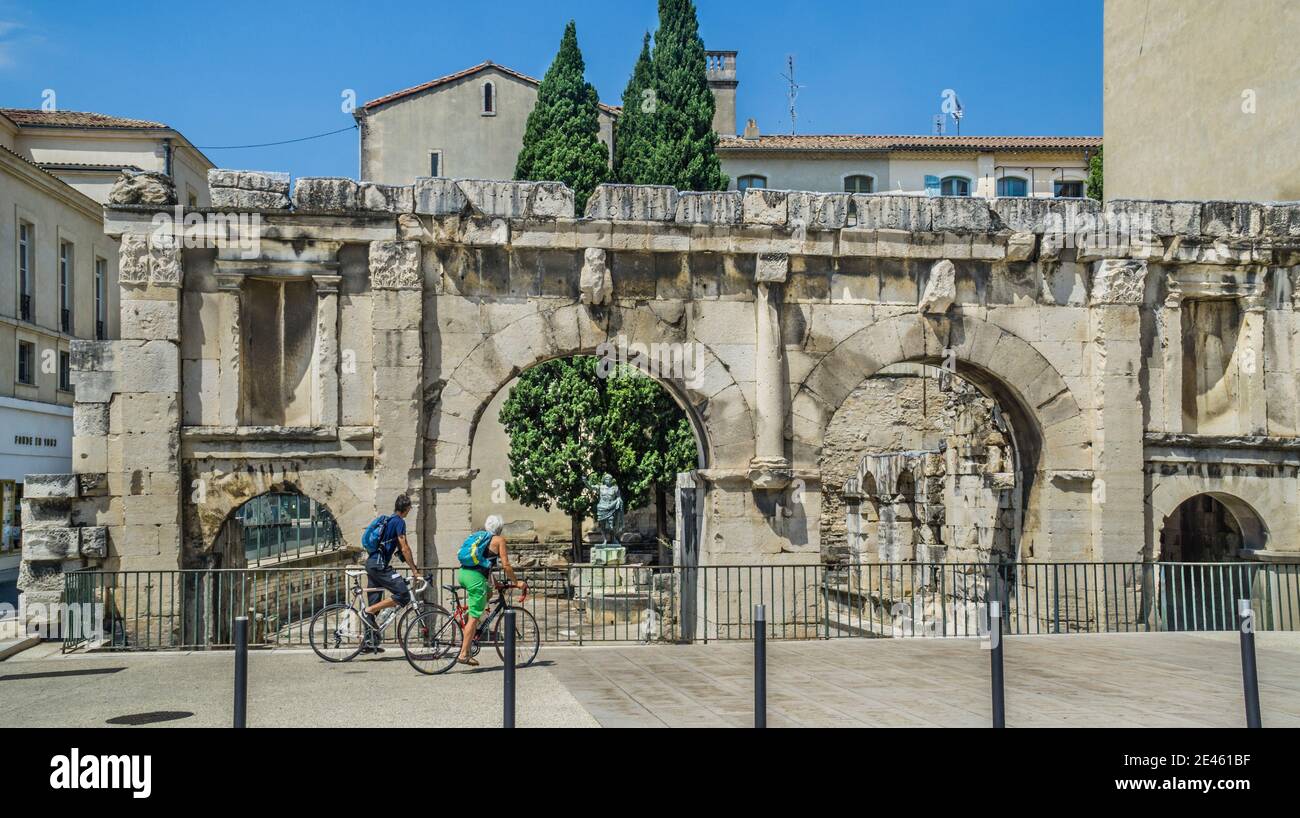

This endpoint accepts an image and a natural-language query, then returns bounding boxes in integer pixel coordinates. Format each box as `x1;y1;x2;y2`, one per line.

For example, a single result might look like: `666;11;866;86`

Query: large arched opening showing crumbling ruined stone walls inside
820;362;1039;563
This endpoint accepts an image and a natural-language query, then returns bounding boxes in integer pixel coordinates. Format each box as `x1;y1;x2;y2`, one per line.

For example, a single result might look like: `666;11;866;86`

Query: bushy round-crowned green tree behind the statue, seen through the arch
499;355;698;559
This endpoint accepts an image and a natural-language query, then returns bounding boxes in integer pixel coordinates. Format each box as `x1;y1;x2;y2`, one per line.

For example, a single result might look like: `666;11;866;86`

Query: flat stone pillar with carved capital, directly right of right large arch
1086;259;1147;562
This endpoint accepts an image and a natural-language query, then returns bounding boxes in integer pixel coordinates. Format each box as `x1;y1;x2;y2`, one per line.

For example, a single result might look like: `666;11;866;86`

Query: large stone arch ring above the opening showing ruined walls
790;312;1093;559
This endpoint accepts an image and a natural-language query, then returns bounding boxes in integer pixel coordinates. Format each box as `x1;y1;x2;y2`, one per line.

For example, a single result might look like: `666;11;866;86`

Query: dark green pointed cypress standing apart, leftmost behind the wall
515;20;610;213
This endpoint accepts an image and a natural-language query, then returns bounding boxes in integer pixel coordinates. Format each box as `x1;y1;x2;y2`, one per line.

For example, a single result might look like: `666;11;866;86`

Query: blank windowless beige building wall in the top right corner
1104;0;1300;202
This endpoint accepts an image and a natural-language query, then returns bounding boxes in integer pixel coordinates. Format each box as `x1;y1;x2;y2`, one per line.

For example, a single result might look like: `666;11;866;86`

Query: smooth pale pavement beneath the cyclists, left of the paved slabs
0;645;597;727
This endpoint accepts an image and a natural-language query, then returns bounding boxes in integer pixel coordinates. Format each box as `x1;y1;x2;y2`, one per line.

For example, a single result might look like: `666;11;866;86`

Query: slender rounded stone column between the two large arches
749;252;790;489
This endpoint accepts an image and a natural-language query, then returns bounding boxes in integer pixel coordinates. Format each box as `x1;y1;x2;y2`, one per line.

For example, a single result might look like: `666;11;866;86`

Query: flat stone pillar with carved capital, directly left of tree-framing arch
369;241;423;568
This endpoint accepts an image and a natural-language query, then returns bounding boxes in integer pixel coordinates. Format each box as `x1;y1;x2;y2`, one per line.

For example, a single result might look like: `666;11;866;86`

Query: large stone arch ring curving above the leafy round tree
425;304;754;472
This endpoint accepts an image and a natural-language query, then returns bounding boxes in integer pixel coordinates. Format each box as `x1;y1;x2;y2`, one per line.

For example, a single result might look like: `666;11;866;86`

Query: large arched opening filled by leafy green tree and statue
469;343;707;567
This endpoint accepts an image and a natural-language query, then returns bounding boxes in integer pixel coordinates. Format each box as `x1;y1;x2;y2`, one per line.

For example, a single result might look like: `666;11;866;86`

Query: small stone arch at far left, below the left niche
182;459;374;567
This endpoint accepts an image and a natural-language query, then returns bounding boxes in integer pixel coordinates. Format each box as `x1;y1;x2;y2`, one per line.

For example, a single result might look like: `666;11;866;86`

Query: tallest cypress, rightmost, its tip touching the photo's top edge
638;0;727;190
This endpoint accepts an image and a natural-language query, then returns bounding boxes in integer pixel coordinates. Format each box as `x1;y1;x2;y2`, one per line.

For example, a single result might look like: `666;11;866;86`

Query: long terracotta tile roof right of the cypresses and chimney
718;134;1101;151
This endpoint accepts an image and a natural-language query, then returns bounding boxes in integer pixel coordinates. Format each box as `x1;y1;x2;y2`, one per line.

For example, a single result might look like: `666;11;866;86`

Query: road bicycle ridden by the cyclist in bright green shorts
402;581;542;676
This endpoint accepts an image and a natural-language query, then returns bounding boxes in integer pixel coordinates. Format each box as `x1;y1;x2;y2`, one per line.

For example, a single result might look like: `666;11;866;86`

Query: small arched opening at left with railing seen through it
212;488;343;568
